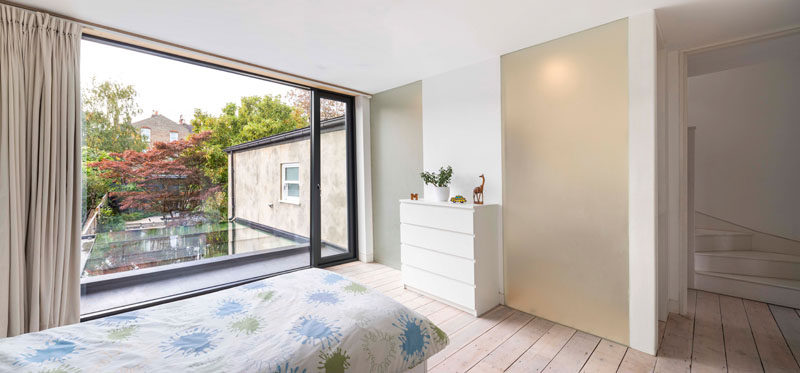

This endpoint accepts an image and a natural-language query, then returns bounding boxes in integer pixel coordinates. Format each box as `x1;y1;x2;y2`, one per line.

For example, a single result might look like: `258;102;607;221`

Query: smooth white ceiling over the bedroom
18;0;800;93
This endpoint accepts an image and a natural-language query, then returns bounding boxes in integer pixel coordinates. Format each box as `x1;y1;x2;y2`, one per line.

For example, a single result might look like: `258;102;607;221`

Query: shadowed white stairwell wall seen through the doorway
688;55;800;240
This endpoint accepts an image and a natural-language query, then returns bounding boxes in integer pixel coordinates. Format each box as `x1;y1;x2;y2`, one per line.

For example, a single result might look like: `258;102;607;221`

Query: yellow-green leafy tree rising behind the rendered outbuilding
192;95;308;185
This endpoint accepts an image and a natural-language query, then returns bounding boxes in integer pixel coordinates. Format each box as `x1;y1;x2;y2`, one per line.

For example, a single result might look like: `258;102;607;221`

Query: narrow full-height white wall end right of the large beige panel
628;11;658;354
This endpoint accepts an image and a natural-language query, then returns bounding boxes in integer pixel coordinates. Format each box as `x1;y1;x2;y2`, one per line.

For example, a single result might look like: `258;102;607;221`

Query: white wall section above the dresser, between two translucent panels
422;57;503;204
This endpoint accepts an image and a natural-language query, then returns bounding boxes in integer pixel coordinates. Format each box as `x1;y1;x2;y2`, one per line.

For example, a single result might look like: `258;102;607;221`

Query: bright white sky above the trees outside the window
81;40;300;122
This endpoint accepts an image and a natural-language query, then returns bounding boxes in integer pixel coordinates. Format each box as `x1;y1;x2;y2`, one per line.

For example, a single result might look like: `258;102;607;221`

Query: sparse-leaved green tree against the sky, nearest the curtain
81;79;147;153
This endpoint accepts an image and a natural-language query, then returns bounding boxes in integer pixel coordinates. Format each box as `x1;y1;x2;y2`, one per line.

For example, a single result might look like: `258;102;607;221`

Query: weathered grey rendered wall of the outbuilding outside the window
228;130;348;248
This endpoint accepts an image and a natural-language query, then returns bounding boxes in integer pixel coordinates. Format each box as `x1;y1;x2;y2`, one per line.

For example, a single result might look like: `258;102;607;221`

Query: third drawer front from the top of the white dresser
400;245;475;284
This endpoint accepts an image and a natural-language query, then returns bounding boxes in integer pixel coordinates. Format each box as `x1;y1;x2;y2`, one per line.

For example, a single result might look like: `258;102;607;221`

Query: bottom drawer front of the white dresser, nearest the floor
402;264;475;310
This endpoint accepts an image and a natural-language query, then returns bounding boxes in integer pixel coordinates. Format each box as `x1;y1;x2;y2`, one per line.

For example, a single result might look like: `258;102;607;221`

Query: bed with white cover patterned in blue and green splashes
0;268;448;373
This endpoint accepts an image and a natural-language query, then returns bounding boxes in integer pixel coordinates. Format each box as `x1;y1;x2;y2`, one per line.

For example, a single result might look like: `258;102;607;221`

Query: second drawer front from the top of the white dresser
400;224;475;259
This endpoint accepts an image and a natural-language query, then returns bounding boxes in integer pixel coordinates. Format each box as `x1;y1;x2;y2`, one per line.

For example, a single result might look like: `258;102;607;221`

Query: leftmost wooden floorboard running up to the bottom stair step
691;291;728;373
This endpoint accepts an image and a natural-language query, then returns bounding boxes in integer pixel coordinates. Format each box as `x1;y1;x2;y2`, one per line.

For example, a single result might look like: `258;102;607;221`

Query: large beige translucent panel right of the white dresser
501;20;629;344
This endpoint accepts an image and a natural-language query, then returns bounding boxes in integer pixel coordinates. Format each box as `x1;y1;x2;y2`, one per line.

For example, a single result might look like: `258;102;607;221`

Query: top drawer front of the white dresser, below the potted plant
400;203;473;234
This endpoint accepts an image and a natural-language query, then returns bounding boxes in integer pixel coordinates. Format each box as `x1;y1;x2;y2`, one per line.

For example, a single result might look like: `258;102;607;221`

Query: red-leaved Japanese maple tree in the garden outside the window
90;131;221;216
